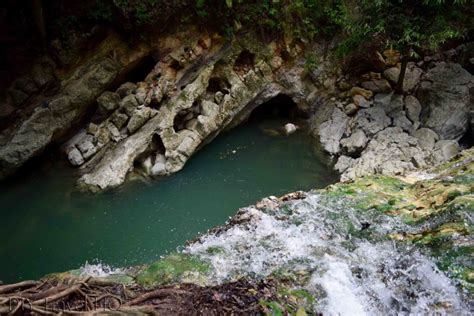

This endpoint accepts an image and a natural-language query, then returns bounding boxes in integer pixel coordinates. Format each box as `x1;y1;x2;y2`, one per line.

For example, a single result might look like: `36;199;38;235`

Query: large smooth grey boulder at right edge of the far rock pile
419;63;474;140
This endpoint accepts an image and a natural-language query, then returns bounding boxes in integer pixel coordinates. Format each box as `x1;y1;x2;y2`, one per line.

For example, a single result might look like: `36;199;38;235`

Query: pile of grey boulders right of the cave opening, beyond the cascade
313;46;474;181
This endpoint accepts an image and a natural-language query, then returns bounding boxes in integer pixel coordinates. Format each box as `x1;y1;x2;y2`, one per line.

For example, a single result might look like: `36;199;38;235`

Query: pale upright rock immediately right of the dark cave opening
318;107;349;155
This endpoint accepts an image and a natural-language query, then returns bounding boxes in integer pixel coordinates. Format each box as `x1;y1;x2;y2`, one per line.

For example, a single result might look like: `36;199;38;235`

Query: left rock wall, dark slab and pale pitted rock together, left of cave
0;29;335;191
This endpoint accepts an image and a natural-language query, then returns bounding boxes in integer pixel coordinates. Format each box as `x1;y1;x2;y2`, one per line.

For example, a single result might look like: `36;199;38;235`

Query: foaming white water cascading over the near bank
184;192;469;315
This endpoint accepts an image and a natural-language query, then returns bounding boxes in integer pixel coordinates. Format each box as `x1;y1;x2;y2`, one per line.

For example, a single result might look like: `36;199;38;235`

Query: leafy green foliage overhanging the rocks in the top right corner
329;0;474;57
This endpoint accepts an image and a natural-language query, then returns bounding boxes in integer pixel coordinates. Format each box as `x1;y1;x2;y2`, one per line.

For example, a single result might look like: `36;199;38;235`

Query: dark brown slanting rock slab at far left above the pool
0;34;149;178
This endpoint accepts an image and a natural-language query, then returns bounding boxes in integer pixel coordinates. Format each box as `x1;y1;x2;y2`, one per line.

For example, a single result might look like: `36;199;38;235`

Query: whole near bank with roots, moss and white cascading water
0;150;474;314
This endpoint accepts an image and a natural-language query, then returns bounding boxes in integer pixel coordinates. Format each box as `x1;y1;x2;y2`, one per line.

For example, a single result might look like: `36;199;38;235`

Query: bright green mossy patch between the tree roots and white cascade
136;253;211;287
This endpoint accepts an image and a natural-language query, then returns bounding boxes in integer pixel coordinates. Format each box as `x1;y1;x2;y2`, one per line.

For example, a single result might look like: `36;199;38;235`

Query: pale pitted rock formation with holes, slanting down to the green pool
72;33;326;192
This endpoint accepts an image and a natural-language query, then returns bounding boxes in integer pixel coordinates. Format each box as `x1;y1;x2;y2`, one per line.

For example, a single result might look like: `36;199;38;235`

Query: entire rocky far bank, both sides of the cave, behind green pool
0;27;474;192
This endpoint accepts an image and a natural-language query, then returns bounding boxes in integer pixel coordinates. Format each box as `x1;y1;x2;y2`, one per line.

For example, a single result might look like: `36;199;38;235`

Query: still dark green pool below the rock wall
0;119;337;282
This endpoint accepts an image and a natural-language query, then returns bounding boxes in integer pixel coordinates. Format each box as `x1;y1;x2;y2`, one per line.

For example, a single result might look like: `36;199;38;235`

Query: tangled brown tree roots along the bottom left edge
0;278;286;315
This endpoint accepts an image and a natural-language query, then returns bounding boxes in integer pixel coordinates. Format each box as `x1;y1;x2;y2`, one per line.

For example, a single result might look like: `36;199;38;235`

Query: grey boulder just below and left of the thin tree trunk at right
354;107;392;137
